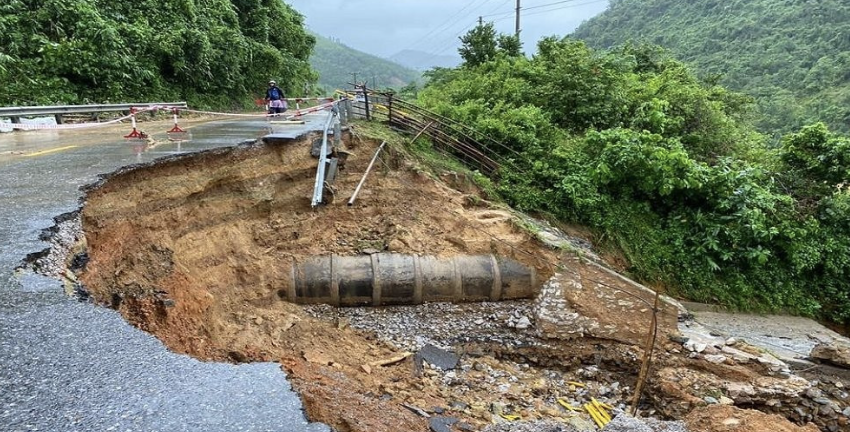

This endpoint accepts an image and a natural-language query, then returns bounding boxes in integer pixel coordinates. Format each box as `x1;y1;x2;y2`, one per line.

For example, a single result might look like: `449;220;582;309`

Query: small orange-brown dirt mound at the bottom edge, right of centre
685;405;818;432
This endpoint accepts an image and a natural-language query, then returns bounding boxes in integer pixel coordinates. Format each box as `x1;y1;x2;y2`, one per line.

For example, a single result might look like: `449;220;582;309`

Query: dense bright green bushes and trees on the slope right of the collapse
419;29;850;323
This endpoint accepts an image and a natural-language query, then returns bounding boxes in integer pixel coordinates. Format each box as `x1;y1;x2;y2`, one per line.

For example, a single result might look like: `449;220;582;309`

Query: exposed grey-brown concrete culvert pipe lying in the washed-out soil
280;253;538;306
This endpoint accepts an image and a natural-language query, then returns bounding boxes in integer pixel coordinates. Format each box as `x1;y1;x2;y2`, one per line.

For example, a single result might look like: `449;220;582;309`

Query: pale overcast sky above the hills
285;0;608;57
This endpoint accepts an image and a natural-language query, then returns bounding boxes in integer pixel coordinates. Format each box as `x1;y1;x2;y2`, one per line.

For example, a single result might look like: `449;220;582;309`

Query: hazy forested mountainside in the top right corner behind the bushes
574;0;850;133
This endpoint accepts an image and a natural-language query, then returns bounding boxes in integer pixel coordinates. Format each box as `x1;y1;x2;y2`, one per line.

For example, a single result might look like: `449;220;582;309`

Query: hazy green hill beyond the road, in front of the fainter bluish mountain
310;34;422;91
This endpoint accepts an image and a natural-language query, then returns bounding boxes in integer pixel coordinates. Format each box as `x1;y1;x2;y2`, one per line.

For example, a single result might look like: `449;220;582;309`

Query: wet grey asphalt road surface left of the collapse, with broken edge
0;114;328;432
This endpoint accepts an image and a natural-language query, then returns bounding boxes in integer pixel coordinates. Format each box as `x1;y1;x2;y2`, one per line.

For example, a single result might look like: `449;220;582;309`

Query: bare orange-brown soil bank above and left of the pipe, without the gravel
80;134;568;431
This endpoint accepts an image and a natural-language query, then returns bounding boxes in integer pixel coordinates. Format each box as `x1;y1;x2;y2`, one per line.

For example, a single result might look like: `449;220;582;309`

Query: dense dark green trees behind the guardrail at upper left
0;0;315;107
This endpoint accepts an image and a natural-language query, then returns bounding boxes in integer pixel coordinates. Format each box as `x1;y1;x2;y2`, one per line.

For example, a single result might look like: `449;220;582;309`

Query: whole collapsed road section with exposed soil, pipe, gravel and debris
31;125;847;431
